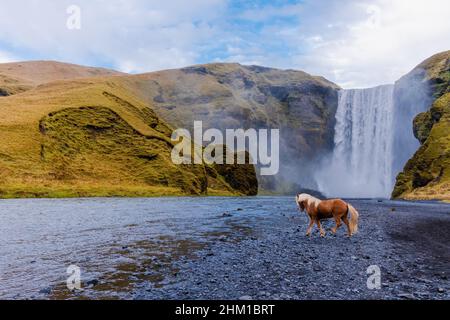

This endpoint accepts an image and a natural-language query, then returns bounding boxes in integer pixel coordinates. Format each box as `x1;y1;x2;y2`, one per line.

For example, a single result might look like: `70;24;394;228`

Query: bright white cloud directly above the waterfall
291;0;450;87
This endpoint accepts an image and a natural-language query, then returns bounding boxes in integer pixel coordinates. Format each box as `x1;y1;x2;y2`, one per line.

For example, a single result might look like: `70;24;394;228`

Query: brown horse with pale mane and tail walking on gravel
296;193;359;237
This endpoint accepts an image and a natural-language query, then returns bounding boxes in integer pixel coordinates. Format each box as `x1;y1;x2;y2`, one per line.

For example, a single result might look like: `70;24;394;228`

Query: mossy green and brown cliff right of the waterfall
392;51;450;200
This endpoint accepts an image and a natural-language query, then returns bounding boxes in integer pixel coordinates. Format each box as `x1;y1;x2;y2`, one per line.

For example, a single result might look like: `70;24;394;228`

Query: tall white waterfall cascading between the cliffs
316;85;395;198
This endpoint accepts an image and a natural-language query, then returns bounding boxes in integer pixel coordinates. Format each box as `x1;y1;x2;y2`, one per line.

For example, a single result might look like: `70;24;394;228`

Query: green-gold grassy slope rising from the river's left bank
0;65;257;198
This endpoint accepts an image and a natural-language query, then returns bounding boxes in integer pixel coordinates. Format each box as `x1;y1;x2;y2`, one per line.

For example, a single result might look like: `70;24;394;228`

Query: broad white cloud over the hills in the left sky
0;0;225;72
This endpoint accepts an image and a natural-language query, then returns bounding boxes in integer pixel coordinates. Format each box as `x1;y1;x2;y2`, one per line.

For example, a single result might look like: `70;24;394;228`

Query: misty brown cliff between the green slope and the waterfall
121;64;339;192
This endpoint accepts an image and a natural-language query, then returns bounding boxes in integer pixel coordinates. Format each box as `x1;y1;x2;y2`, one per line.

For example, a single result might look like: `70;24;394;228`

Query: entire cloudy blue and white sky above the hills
0;0;450;88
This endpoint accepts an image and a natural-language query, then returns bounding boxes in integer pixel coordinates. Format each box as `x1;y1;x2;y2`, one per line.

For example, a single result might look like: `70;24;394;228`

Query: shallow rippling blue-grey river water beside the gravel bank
0;197;448;299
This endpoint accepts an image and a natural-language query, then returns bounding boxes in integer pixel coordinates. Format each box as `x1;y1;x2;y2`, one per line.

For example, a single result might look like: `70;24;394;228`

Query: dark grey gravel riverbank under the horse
135;200;450;299
